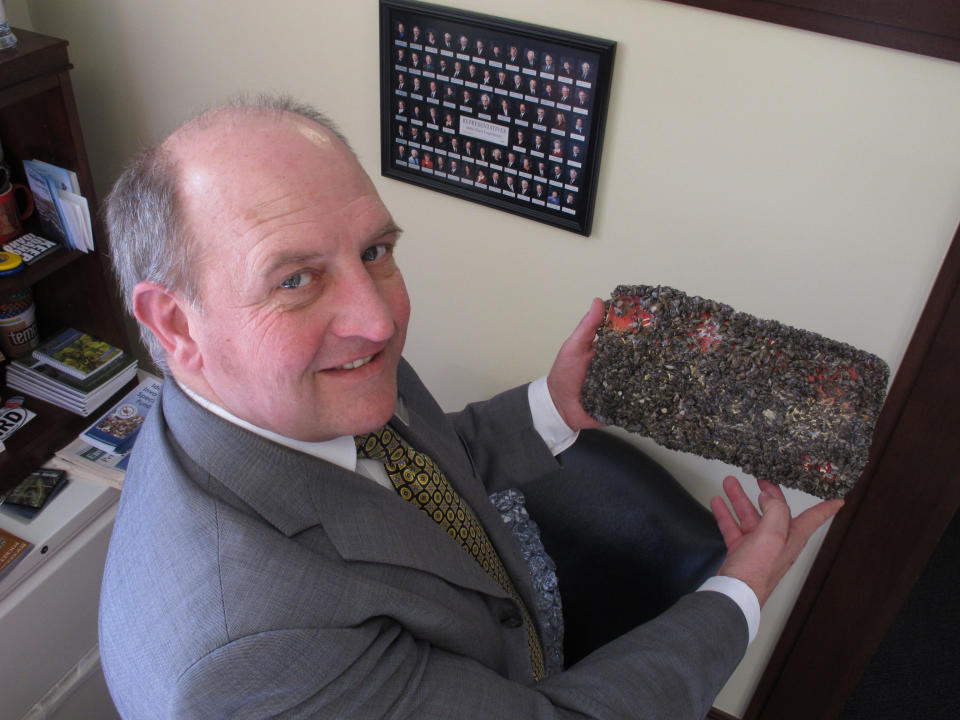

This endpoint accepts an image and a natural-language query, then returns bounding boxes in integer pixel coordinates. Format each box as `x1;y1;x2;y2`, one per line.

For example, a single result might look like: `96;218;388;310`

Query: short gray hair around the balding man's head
106;95;352;372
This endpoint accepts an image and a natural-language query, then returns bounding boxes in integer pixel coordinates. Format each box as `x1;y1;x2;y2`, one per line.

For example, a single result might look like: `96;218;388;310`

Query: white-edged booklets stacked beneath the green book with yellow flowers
7;355;137;417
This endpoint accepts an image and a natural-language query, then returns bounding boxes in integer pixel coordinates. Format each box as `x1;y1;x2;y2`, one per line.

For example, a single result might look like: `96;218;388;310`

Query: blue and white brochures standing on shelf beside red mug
23;160;93;252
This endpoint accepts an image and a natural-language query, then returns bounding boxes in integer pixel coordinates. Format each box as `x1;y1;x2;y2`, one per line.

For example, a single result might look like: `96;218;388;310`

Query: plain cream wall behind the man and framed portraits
15;0;960;716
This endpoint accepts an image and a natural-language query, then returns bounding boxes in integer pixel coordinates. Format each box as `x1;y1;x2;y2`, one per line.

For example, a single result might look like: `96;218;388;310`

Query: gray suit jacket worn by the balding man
100;363;746;720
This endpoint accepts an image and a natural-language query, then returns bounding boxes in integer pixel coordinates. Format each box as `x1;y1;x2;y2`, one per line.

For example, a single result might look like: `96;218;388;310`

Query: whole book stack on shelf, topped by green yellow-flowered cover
7;328;137;417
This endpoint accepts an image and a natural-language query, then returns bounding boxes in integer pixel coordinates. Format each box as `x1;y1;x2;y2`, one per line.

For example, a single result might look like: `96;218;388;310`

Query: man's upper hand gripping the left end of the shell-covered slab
547;298;603;430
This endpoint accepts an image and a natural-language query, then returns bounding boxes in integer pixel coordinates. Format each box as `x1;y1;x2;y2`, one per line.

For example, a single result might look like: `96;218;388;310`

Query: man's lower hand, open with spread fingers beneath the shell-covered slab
710;477;843;607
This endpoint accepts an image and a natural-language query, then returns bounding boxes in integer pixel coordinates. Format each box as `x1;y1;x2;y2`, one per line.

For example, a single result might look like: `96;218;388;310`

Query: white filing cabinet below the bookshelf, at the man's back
0;477;120;720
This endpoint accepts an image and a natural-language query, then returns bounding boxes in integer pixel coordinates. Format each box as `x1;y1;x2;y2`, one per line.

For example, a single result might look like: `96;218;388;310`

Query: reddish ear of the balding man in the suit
133;282;203;370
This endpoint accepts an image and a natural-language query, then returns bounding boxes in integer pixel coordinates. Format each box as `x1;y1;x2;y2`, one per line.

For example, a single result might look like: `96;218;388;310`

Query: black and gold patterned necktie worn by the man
355;425;546;681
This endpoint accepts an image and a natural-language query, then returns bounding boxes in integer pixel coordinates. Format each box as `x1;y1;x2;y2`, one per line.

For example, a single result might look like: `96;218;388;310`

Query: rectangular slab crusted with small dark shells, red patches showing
582;285;890;498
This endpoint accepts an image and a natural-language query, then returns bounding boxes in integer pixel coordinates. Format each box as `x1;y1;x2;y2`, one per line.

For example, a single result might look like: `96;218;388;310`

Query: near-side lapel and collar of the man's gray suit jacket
162;380;514;597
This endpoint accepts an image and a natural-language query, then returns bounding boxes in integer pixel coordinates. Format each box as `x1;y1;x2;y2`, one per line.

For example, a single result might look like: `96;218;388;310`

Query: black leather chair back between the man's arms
523;430;726;666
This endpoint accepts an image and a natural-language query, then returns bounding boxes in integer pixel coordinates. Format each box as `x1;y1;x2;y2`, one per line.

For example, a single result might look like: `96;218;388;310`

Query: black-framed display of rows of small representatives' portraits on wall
380;0;616;235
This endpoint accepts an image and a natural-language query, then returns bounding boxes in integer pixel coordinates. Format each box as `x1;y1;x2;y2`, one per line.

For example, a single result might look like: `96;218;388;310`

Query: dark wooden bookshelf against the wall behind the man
0;28;130;493
